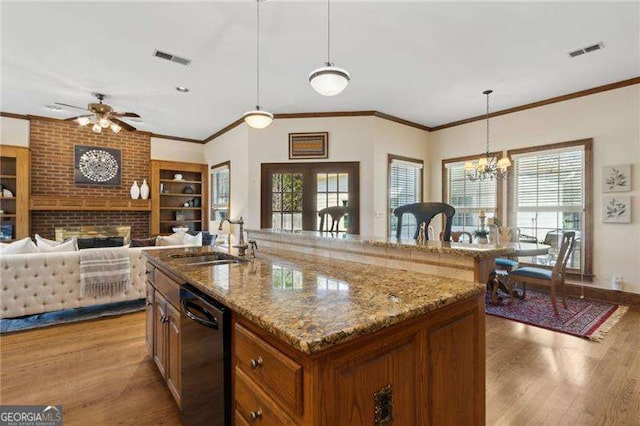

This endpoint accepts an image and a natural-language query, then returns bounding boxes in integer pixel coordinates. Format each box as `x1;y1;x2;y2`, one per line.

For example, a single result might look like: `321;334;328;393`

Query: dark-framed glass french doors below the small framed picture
260;162;360;234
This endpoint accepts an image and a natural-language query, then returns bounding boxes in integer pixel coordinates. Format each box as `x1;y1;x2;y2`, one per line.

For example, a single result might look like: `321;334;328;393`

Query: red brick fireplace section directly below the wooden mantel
31;211;149;239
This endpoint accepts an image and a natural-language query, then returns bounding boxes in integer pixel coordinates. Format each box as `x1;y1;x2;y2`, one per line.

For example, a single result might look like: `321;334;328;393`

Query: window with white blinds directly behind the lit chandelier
442;153;502;232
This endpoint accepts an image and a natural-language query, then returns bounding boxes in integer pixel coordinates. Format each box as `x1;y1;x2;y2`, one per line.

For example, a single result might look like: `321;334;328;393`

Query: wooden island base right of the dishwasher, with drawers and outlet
233;295;485;426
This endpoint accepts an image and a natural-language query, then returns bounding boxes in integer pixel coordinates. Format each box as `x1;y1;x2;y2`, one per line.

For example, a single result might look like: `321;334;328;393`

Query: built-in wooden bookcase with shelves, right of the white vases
151;161;209;235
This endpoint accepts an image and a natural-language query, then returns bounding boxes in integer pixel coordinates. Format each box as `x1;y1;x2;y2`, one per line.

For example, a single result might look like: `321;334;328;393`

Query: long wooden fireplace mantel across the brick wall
29;195;151;212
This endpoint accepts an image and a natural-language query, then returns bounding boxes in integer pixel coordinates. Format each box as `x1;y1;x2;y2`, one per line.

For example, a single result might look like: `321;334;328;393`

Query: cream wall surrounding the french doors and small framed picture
205;116;428;235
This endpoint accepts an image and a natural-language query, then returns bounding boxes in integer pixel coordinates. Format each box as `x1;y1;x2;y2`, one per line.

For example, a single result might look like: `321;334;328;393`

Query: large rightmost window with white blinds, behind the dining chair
508;139;592;275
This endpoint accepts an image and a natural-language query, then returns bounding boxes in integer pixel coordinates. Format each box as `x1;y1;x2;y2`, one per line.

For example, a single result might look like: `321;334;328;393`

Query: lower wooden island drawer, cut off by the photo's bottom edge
235;368;295;426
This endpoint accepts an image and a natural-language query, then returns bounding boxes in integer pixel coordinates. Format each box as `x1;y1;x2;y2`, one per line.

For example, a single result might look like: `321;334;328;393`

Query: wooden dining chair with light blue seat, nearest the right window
508;231;576;316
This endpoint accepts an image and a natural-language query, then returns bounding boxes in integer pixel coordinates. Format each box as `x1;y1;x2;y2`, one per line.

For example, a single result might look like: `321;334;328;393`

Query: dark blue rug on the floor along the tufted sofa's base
0;299;145;334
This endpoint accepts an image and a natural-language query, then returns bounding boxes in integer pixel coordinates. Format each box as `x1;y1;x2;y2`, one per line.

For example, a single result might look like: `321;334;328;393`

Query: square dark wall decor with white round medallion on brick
74;145;122;186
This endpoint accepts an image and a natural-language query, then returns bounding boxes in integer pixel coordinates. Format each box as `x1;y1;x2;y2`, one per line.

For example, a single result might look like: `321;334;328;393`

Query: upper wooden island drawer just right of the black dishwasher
235;325;302;414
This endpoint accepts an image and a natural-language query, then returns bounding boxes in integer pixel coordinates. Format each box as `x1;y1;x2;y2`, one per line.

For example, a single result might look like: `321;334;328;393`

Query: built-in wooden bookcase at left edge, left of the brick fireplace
0;145;29;242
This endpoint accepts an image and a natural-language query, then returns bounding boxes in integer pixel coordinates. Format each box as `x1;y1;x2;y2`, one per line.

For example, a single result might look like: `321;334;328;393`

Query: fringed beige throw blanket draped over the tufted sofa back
80;247;131;297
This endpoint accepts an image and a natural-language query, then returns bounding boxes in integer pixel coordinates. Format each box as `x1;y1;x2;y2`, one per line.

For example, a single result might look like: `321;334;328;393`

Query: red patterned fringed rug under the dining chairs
485;290;629;341
